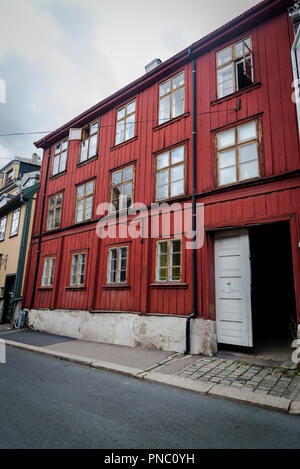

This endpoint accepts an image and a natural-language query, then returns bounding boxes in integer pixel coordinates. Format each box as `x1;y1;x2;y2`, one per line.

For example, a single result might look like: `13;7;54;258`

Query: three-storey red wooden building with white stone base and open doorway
24;0;300;354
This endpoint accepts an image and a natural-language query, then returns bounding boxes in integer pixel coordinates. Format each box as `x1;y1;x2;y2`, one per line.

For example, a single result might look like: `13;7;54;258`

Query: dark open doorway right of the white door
248;222;297;353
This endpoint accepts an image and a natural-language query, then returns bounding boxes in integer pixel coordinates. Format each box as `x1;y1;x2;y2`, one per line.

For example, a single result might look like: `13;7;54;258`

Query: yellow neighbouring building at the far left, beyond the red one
0;154;41;324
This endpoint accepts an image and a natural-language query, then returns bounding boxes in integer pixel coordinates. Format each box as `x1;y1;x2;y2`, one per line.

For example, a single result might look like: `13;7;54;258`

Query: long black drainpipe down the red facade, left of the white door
184;49;198;355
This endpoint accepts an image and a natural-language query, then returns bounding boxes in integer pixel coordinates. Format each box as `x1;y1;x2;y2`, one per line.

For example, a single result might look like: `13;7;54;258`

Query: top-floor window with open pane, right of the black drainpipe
217;36;254;98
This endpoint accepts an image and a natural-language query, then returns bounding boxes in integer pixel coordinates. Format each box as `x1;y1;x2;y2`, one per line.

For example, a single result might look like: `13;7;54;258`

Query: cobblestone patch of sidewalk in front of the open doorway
177;357;300;400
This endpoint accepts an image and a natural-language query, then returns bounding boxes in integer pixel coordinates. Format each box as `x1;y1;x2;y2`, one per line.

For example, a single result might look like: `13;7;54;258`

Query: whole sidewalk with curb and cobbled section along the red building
0;325;300;415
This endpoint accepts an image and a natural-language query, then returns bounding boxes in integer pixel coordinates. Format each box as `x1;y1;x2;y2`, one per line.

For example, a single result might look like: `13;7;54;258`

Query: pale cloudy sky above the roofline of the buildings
0;0;258;167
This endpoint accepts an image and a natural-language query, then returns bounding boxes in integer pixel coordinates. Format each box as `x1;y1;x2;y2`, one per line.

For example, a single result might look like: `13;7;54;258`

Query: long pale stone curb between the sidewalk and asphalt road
1;339;300;415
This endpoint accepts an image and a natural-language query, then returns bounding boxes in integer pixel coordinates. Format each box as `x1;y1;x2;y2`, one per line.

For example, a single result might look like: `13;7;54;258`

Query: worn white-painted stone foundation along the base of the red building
27;309;217;356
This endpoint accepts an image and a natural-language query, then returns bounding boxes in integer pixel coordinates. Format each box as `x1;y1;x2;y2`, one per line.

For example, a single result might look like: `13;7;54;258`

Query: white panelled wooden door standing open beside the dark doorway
215;230;253;347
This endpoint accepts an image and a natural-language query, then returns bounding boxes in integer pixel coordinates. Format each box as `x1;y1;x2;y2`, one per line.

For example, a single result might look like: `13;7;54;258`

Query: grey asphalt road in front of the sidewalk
0;347;300;449
